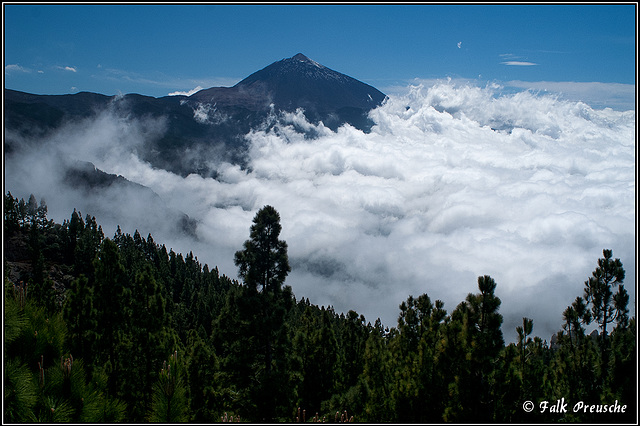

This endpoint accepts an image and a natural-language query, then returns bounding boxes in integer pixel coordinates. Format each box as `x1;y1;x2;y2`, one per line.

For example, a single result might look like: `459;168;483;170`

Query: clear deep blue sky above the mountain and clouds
3;3;636;104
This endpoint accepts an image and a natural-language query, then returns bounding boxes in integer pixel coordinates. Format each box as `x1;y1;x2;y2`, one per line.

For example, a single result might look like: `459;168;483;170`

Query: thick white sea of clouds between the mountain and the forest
5;80;636;341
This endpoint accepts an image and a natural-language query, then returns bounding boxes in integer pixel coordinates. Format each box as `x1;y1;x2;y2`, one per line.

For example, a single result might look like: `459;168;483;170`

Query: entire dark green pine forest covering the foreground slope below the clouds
4;194;637;423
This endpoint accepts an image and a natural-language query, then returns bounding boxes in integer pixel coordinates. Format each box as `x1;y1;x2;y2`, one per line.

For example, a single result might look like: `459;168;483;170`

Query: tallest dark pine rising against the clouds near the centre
216;206;293;421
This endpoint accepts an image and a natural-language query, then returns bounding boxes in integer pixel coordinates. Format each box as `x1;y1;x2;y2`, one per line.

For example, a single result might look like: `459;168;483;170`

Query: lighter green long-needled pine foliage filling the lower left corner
4;276;125;423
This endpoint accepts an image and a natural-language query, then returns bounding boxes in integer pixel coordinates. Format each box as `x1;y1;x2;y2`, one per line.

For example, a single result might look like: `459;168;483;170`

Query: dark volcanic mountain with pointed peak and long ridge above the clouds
4;54;386;176
